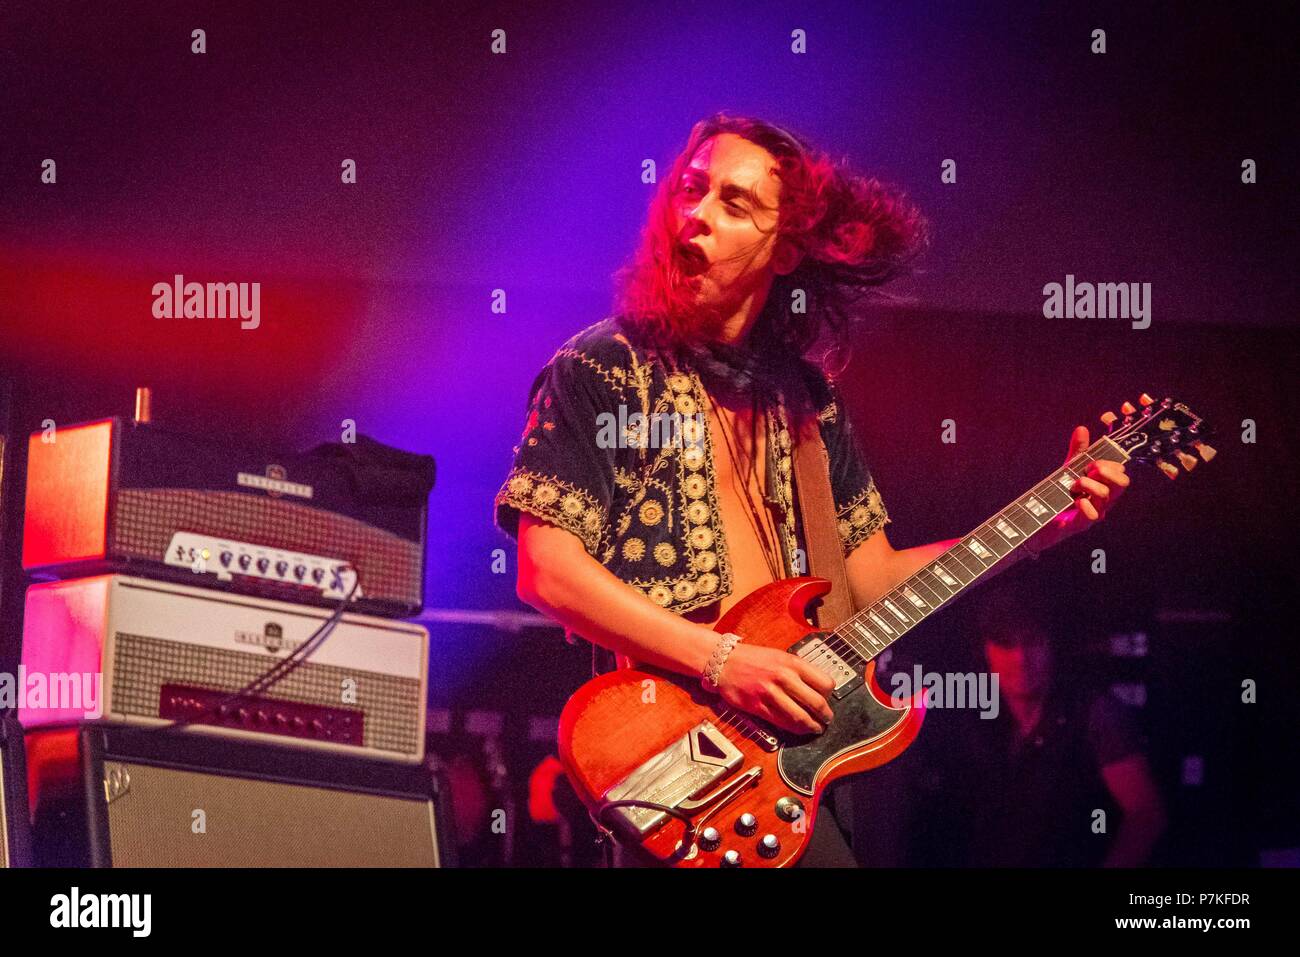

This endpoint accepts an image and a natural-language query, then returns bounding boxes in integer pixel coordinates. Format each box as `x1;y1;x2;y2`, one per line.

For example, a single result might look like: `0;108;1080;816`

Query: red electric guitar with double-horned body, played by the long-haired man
559;395;1214;867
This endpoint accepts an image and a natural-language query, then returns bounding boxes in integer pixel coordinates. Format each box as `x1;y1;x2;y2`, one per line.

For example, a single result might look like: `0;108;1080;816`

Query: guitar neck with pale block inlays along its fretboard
835;437;1128;661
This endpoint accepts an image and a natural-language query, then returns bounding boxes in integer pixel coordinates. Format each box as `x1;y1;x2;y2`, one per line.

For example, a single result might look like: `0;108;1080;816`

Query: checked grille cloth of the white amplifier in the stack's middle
113;632;424;754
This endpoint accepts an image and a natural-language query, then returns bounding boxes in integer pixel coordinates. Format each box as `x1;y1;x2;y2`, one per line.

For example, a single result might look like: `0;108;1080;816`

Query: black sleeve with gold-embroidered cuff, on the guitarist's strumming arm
495;350;618;559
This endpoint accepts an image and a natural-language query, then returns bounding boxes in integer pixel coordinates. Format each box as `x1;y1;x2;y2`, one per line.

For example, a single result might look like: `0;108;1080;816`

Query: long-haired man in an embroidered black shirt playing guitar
495;114;1128;866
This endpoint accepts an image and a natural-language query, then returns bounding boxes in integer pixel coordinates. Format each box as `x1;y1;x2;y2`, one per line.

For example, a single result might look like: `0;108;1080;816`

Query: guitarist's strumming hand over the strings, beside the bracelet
718;641;835;735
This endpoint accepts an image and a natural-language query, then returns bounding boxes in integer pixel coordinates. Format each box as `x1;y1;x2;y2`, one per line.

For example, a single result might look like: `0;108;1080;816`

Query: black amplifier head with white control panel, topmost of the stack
22;419;434;616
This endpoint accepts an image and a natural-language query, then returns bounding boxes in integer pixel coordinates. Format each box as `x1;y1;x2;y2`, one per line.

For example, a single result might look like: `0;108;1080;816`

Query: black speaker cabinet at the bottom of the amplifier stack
26;724;456;867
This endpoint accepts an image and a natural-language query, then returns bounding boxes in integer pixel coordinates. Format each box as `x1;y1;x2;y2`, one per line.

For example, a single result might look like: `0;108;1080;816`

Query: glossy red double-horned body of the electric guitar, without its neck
559;577;924;867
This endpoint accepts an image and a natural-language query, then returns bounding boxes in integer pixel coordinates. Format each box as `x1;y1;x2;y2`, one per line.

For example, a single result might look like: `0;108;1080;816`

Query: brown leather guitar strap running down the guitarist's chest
792;377;854;631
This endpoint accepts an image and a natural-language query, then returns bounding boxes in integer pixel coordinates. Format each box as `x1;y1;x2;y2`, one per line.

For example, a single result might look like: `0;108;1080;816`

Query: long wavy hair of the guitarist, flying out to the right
615;113;928;374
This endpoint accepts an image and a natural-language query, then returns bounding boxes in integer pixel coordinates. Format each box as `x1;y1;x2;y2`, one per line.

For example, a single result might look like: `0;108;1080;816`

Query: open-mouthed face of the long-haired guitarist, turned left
672;133;793;315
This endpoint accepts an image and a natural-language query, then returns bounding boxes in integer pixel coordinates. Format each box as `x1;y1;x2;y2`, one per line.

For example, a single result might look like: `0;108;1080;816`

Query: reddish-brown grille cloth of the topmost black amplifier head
113;489;421;605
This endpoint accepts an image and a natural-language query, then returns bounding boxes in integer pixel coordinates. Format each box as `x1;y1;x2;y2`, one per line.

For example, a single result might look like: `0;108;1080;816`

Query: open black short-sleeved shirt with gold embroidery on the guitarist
495;319;889;614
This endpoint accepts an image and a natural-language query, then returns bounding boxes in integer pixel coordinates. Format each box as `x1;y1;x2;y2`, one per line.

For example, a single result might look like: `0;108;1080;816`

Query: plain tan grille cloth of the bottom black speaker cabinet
105;761;438;867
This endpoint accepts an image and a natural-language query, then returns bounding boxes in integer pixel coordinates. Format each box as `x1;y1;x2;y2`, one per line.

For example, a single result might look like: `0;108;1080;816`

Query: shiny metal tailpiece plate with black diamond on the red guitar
605;722;744;841
